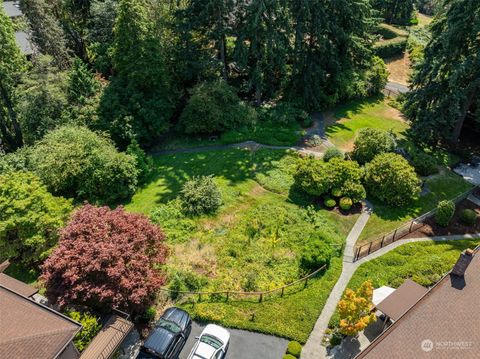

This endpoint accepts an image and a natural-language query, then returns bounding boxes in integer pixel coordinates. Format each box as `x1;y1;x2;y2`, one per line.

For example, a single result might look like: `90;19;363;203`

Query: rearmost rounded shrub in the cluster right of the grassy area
353;128;395;163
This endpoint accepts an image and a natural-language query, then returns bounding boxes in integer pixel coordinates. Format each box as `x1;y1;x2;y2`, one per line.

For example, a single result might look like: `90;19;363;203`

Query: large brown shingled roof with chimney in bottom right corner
357;248;480;359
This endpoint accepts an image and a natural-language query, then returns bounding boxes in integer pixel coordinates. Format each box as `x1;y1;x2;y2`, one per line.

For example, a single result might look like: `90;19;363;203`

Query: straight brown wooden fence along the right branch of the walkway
353;187;478;262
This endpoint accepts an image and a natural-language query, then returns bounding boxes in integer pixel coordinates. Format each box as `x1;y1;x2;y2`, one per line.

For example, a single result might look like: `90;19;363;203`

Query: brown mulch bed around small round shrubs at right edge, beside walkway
404;199;480;238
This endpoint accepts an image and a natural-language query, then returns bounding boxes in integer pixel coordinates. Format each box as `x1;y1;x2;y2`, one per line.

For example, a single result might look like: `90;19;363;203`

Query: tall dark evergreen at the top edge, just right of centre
235;0;290;105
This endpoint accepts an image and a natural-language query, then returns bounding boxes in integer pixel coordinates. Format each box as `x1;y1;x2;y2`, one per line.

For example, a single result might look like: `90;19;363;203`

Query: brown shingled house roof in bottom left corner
0;285;81;359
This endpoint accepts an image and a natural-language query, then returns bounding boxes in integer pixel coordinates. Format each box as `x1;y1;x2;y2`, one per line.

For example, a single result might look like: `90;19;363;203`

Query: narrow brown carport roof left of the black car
80;315;133;359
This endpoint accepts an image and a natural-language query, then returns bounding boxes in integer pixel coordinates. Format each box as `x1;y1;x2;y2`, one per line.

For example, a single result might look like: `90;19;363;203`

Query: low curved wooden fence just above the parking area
160;264;327;303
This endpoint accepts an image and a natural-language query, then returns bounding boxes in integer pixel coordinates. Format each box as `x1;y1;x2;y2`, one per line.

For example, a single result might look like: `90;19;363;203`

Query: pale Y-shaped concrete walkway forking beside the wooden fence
302;231;480;359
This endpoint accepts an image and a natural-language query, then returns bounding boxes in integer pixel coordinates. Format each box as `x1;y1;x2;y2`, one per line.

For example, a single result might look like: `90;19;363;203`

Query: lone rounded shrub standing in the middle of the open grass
180;176;222;216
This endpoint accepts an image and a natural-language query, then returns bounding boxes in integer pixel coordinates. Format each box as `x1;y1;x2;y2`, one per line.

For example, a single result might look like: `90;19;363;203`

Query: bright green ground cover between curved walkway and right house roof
330;239;479;327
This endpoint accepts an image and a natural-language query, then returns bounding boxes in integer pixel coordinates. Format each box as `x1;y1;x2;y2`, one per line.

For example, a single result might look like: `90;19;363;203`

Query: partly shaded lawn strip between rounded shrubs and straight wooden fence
359;169;472;242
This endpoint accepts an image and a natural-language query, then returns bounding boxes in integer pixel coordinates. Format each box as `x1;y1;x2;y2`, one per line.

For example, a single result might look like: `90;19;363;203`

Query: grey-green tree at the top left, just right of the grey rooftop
20;0;70;70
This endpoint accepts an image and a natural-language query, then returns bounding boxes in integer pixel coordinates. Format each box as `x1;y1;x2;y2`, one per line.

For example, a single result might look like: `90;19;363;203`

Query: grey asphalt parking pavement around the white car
179;322;288;359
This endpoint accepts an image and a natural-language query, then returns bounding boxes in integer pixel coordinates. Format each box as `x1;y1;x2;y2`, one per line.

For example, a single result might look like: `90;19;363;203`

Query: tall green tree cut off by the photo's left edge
0;7;27;151
